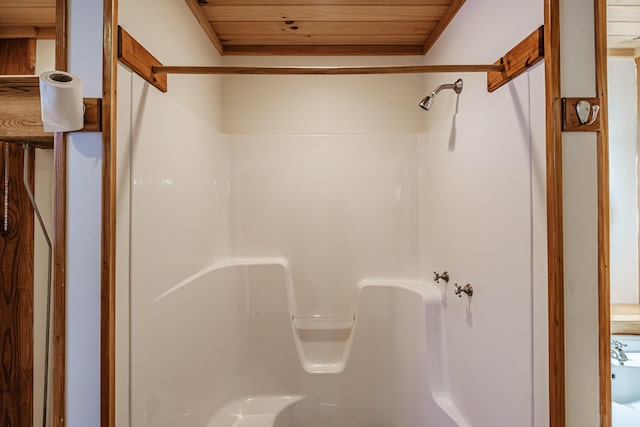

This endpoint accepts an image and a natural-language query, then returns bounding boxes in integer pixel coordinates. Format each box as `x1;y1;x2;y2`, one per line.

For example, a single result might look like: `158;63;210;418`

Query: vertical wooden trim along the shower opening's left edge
100;0;118;427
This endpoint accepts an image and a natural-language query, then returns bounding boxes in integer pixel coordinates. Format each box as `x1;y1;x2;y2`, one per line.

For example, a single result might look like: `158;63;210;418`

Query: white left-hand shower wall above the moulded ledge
116;0;231;426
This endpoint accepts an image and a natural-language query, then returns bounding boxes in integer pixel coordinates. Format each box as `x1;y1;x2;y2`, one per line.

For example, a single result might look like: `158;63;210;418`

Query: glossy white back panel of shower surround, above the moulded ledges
230;134;418;318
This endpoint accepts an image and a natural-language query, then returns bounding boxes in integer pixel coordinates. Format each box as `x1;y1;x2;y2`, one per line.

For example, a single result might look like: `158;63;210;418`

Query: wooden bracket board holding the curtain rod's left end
117;26;167;92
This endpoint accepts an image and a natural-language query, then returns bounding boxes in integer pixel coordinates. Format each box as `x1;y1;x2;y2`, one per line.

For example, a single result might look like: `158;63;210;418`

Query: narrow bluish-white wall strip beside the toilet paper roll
66;0;102;427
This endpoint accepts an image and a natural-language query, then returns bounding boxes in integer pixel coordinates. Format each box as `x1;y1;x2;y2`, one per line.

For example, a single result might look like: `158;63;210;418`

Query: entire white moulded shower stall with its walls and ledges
116;0;548;427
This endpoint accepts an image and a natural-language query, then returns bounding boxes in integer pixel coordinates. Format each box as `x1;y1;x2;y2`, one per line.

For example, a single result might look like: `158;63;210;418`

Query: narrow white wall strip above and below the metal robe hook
560;0;600;427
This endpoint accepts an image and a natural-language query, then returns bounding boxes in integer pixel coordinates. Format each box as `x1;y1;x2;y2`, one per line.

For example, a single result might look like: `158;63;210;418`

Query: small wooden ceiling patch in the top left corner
0;0;56;39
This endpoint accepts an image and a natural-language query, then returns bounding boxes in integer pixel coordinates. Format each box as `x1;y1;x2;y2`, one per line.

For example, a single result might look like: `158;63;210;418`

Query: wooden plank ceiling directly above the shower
185;0;465;55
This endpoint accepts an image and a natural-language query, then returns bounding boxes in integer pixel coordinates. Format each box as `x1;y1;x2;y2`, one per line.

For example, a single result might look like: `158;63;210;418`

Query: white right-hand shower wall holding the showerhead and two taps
419;0;549;427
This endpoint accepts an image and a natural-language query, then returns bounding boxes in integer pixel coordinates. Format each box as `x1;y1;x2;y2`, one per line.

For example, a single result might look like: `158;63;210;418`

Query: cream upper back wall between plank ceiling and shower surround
223;56;424;135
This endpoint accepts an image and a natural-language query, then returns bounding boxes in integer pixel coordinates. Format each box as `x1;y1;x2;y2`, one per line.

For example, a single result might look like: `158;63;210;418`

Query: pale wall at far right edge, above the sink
607;58;638;303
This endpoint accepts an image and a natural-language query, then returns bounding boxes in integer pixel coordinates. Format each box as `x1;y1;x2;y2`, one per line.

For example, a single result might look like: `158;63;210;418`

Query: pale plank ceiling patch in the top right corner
607;0;640;56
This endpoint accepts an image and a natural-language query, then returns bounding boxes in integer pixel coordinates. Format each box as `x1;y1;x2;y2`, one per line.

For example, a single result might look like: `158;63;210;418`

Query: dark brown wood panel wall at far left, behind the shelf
0;39;35;427
